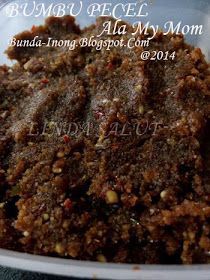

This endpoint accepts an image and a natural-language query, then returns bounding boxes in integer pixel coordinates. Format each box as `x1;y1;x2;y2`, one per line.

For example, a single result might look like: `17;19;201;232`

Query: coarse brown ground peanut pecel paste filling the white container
0;16;210;264
